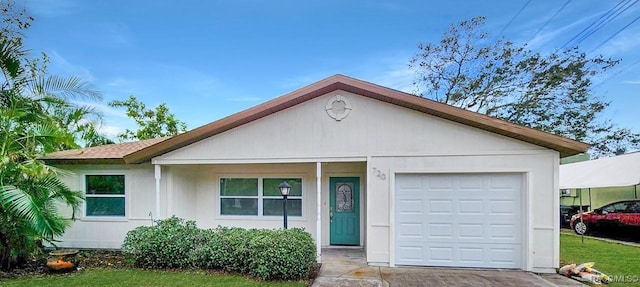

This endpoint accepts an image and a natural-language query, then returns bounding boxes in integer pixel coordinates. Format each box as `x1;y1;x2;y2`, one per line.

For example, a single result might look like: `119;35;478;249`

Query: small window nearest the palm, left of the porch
85;174;126;216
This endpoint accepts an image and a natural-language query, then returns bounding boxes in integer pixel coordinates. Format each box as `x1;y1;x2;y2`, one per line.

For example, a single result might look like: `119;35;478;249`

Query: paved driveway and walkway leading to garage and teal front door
312;248;584;287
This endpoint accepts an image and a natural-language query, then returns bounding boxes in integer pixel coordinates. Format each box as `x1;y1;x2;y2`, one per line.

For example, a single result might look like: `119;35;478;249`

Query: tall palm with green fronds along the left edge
0;1;100;269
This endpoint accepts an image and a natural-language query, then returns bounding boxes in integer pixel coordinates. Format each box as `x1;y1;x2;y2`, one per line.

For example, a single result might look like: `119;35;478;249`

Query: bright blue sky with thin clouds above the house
18;0;640;140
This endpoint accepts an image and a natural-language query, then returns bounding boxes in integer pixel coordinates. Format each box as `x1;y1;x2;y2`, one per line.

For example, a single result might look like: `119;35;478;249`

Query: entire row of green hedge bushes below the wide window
122;217;316;280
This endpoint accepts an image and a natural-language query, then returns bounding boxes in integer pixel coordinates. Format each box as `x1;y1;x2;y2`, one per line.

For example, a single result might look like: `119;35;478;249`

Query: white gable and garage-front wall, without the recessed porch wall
154;91;559;272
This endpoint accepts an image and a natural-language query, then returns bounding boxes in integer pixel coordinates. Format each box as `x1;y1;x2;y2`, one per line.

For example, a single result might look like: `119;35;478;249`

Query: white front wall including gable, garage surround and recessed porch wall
58;91;559;272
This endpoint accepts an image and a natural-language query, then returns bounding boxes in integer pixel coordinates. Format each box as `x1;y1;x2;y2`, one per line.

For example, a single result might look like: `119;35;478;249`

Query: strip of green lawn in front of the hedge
0;269;305;287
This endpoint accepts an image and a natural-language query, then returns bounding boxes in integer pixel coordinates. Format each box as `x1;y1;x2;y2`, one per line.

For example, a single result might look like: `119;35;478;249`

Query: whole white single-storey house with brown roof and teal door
46;75;588;272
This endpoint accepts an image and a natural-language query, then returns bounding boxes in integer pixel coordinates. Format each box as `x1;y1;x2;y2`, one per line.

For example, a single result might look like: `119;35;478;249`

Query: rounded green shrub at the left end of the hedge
122;216;205;268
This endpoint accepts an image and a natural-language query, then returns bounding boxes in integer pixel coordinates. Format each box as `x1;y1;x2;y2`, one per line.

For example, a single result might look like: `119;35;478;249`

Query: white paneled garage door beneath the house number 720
395;174;522;268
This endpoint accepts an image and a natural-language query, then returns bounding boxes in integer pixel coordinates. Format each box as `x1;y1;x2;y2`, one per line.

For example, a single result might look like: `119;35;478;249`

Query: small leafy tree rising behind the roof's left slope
109;96;187;141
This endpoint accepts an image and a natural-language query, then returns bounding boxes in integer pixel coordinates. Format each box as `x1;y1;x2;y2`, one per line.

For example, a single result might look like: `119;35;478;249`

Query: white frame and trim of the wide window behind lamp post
219;175;305;220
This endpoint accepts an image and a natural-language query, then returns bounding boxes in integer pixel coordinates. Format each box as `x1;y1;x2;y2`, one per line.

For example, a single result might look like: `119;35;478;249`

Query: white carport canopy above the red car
560;152;640;189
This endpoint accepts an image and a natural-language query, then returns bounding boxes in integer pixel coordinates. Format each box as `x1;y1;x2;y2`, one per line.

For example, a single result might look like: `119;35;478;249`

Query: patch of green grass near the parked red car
560;234;640;287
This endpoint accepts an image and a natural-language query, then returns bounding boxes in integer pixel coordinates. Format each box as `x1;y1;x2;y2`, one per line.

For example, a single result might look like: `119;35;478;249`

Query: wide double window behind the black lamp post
220;178;302;216
